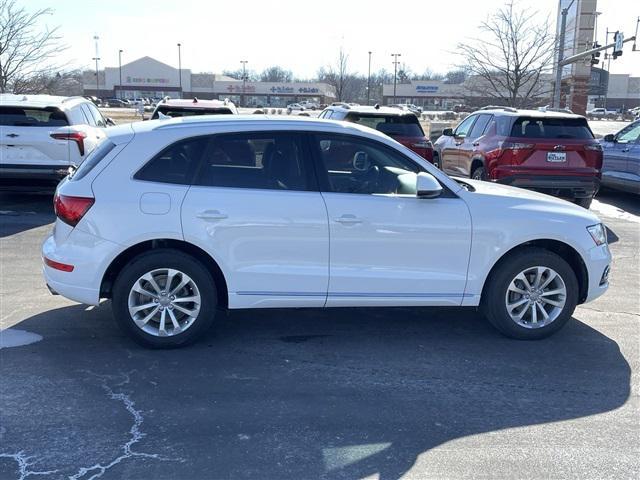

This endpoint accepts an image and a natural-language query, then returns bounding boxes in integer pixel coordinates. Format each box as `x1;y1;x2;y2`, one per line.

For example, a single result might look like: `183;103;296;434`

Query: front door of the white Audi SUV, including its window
312;134;471;306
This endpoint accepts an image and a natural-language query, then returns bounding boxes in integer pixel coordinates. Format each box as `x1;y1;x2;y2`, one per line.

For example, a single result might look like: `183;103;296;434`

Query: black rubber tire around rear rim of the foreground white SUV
112;248;218;348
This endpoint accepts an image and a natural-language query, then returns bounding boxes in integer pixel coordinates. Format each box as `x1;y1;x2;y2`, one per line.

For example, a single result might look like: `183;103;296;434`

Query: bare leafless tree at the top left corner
0;0;64;93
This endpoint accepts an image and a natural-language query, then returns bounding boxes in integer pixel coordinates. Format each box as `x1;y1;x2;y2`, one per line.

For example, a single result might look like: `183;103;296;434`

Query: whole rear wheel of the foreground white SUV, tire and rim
113;249;217;348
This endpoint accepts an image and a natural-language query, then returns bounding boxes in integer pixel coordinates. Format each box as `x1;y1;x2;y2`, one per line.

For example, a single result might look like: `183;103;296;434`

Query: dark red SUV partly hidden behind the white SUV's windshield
319;104;433;163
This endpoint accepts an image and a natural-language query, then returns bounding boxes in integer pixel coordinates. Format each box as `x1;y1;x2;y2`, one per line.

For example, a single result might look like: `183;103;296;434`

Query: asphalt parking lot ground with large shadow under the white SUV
0;188;640;480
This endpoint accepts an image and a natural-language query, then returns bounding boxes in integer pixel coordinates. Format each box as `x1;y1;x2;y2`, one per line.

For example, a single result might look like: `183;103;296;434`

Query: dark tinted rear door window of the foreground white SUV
194;132;309;190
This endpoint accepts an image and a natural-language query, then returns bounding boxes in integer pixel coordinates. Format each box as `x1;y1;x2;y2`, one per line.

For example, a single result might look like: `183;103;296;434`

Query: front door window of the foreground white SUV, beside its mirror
314;134;422;195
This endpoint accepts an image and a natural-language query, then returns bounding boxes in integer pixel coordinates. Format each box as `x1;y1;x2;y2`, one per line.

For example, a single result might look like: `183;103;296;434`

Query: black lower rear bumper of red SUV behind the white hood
496;173;600;198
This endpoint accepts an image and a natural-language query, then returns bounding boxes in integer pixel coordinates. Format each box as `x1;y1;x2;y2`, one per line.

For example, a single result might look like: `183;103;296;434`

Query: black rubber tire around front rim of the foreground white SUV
481;247;578;340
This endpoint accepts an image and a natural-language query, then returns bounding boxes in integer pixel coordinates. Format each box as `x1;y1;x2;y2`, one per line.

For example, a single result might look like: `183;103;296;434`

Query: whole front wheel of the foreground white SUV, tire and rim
482;247;578;340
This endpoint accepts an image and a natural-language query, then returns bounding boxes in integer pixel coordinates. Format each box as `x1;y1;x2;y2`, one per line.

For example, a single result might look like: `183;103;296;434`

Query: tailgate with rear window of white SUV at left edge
0;105;70;168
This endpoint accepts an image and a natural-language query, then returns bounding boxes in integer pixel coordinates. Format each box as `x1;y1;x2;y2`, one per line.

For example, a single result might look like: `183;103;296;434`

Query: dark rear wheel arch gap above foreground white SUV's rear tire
100;238;229;308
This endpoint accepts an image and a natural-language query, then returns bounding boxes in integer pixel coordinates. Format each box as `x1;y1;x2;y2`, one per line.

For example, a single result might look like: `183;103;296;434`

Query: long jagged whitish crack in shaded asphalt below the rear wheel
68;370;184;480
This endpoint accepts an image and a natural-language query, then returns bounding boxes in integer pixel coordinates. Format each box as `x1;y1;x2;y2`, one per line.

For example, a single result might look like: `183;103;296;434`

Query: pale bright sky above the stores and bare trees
32;0;640;78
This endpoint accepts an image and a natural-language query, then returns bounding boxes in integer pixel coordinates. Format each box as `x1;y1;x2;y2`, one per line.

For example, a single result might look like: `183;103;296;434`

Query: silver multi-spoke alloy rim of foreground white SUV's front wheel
505;266;567;328
